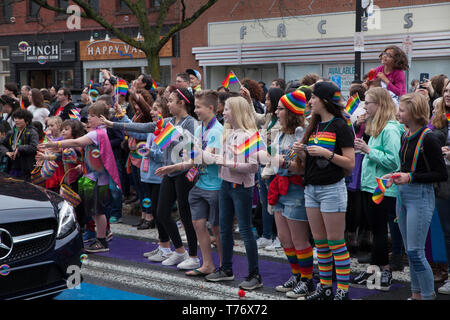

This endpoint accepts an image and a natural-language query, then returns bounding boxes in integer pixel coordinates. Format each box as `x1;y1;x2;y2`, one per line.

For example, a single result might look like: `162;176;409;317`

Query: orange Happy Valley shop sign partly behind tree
80;39;172;61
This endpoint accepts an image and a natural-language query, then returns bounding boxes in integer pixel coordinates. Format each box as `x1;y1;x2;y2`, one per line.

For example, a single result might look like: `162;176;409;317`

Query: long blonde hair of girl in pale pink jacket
223;97;258;144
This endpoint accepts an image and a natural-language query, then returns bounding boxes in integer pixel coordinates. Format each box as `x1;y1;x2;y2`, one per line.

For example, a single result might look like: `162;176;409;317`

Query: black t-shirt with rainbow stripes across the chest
304;118;354;185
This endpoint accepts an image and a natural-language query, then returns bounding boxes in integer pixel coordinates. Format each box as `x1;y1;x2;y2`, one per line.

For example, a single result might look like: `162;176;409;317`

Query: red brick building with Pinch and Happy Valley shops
0;0;179;93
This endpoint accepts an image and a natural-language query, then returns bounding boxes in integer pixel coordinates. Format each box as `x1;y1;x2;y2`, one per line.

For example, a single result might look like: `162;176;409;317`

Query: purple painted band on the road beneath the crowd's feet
97;236;404;299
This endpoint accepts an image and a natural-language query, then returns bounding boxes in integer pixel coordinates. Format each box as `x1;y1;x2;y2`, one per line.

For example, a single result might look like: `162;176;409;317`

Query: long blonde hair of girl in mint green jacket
366;87;397;138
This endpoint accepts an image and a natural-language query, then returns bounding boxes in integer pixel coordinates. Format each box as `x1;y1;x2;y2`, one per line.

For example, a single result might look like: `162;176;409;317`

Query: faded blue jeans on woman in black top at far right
397;184;435;300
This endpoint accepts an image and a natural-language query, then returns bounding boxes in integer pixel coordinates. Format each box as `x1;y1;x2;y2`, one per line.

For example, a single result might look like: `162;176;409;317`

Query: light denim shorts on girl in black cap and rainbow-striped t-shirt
305;179;347;213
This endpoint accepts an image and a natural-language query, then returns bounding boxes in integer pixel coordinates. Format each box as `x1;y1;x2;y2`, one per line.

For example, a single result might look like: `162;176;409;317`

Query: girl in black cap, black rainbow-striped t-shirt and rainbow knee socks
293;81;355;300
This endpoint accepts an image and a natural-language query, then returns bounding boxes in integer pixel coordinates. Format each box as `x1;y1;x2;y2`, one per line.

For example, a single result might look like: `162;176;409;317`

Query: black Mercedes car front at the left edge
0;173;83;300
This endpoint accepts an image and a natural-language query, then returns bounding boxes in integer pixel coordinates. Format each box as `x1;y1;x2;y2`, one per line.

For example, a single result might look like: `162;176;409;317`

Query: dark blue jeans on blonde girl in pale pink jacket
219;180;259;274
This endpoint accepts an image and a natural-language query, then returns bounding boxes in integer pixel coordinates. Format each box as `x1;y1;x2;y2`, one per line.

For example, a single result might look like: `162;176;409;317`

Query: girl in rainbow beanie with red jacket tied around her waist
260;91;314;298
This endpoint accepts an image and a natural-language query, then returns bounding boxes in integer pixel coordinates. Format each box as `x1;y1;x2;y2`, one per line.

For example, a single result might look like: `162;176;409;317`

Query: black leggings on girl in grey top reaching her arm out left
156;173;197;257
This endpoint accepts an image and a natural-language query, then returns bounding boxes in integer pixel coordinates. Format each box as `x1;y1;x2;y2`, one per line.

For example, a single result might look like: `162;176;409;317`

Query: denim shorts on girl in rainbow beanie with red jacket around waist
273;183;308;221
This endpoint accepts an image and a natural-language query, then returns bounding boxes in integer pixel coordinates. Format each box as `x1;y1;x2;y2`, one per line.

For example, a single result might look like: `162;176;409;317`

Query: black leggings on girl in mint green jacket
363;191;397;266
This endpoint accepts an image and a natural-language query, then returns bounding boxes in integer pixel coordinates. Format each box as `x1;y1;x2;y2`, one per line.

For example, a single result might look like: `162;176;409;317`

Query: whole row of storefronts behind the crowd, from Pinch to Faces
0;0;450;94
